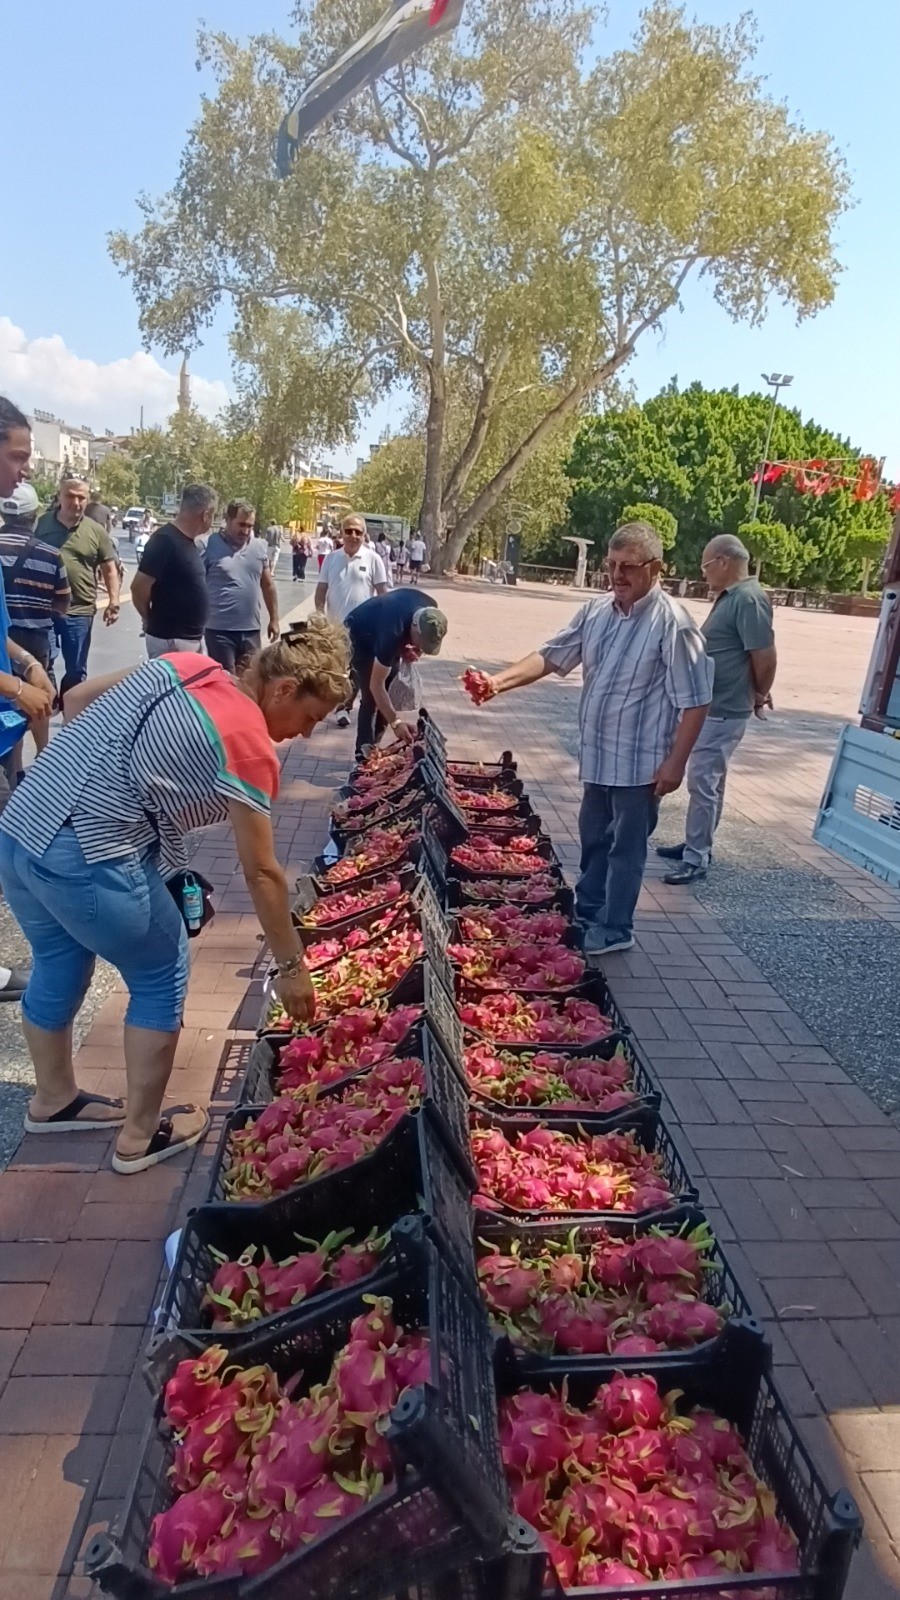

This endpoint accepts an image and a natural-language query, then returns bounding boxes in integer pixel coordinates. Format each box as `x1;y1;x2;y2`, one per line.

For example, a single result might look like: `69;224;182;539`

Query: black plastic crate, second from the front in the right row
472;1206;757;1384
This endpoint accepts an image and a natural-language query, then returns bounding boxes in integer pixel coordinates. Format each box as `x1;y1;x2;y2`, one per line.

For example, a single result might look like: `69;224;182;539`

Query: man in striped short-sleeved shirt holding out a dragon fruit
477;522;713;957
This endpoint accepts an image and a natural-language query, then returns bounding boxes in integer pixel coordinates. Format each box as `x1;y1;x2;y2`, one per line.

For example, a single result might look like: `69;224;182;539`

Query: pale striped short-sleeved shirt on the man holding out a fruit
540;586;713;789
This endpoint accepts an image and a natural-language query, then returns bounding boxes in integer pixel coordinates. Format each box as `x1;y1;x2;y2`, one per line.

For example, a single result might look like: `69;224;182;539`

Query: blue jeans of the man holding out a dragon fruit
575;784;660;942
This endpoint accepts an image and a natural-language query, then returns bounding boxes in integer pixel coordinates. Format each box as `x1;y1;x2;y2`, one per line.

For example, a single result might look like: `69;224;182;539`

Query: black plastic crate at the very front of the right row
495;1322;863;1600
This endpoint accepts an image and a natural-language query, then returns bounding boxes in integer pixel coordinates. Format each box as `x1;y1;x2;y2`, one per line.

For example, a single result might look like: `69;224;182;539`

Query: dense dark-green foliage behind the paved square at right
567;381;890;589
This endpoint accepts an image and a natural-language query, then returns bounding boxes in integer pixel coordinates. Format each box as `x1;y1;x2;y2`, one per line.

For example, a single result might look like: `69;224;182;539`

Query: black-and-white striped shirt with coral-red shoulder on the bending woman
0;651;279;877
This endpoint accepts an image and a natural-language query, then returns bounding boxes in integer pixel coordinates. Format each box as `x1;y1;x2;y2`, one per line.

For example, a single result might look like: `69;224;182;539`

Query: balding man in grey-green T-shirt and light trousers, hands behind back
657;533;777;883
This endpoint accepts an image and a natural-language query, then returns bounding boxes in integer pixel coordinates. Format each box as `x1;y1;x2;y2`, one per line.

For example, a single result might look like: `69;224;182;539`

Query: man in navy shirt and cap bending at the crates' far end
344;589;447;762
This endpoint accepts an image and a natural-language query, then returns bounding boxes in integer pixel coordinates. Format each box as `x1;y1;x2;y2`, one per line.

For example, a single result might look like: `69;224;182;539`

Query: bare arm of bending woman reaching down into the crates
227;800;315;1022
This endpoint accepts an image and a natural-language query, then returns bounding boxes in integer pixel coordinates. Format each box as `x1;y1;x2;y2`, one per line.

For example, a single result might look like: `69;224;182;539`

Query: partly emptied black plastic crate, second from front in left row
147;1117;474;1389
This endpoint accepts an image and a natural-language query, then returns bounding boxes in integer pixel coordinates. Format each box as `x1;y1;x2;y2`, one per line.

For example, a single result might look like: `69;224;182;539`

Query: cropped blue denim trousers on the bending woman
0;826;187;1034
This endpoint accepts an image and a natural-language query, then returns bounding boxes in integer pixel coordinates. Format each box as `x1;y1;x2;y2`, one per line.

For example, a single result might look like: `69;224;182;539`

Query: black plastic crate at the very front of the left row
85;1251;509;1600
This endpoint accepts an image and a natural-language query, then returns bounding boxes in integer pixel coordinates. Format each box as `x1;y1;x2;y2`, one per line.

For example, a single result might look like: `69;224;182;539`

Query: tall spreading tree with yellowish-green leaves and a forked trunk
110;0;847;568
